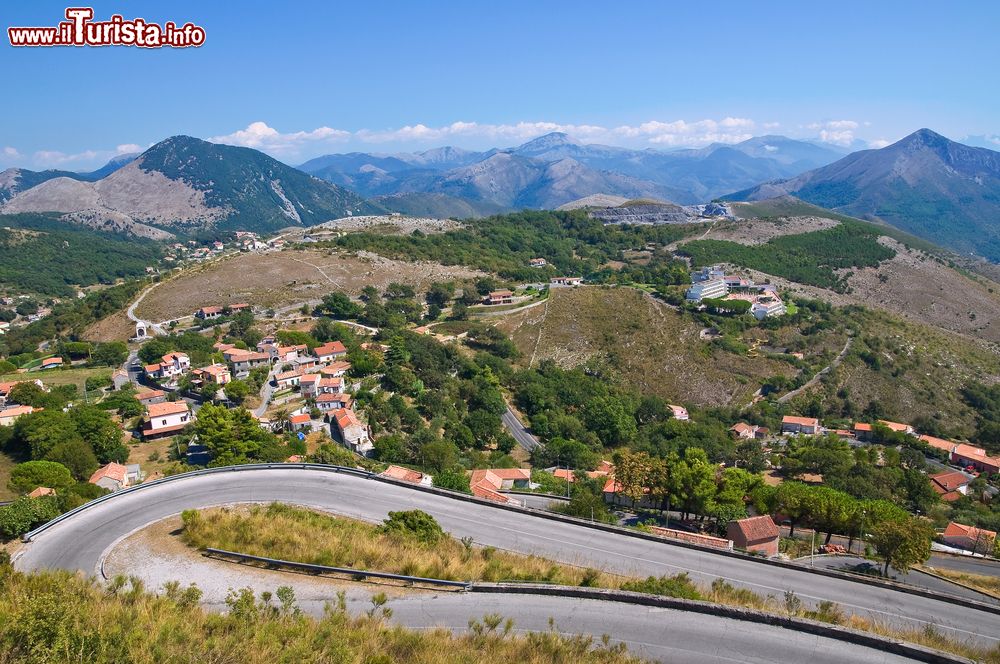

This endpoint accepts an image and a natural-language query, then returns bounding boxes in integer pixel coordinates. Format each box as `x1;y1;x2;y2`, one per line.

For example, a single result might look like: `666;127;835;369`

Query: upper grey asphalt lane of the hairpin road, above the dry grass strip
15;466;1000;661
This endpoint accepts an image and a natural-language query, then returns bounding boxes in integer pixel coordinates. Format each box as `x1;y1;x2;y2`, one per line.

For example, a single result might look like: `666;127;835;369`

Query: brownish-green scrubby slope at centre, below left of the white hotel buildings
500;287;795;405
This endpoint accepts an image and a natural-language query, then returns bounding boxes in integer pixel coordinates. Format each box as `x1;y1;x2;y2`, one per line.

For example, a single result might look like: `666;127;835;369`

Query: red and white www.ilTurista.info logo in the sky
7;7;205;48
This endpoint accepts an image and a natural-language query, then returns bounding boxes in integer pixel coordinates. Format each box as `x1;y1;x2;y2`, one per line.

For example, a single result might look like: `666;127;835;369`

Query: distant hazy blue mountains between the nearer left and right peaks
299;132;842;213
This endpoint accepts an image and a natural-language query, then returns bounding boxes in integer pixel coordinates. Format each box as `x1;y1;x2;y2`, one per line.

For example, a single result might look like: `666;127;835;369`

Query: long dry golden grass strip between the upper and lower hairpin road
181;504;1000;664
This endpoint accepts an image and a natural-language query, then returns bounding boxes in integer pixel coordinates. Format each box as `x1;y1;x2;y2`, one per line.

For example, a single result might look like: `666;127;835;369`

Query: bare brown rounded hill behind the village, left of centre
137;249;482;321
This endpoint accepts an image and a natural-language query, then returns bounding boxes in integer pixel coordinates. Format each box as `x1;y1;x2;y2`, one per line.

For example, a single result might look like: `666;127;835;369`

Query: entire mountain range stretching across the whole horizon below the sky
0;129;1000;261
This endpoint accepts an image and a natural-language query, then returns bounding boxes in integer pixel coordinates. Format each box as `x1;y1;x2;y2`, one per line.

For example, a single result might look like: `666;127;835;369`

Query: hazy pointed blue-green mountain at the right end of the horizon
726;129;1000;261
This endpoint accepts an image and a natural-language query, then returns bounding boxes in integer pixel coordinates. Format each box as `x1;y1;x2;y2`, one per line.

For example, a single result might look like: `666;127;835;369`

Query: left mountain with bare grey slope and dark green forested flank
0;136;382;239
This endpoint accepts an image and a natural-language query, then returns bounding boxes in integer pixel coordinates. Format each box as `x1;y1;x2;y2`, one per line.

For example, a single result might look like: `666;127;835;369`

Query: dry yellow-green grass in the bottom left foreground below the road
0;565;639;664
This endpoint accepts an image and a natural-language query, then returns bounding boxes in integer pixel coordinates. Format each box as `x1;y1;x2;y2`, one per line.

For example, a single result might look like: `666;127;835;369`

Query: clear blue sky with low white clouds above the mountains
0;0;1000;169
